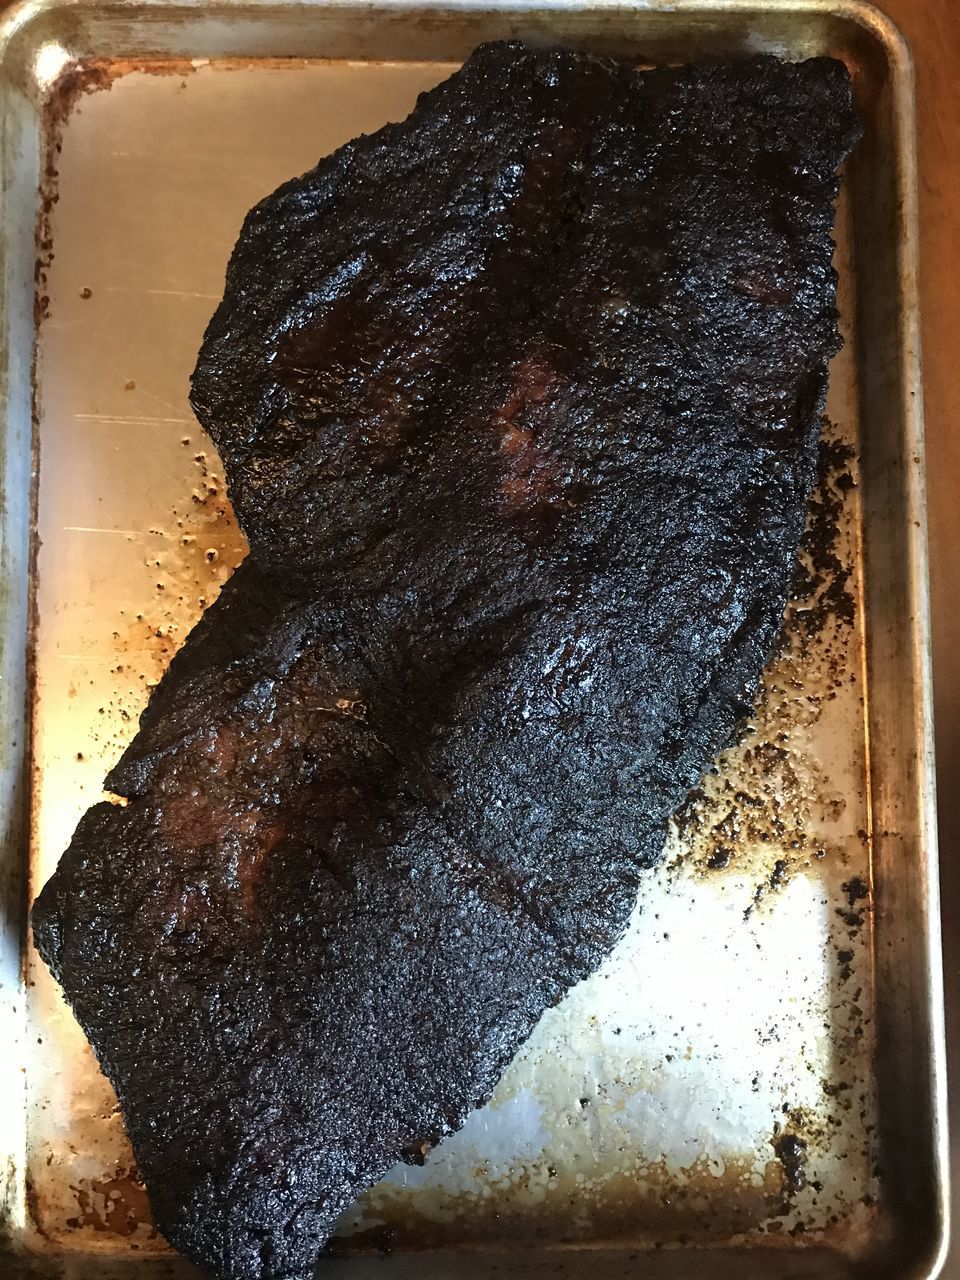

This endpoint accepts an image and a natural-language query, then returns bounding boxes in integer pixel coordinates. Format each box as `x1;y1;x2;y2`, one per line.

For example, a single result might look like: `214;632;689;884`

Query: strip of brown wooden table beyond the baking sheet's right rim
879;0;960;1264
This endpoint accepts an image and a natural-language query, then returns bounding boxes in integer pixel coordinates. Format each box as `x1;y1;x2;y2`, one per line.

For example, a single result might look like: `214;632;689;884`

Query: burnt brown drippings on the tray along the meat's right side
660;421;874;1249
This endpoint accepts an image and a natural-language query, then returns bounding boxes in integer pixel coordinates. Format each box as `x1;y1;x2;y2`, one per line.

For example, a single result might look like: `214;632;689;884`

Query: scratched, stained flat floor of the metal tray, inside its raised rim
0;2;947;1277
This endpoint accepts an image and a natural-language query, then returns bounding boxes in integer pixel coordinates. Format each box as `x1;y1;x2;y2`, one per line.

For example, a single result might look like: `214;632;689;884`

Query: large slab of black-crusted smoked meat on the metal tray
33;44;856;1280
